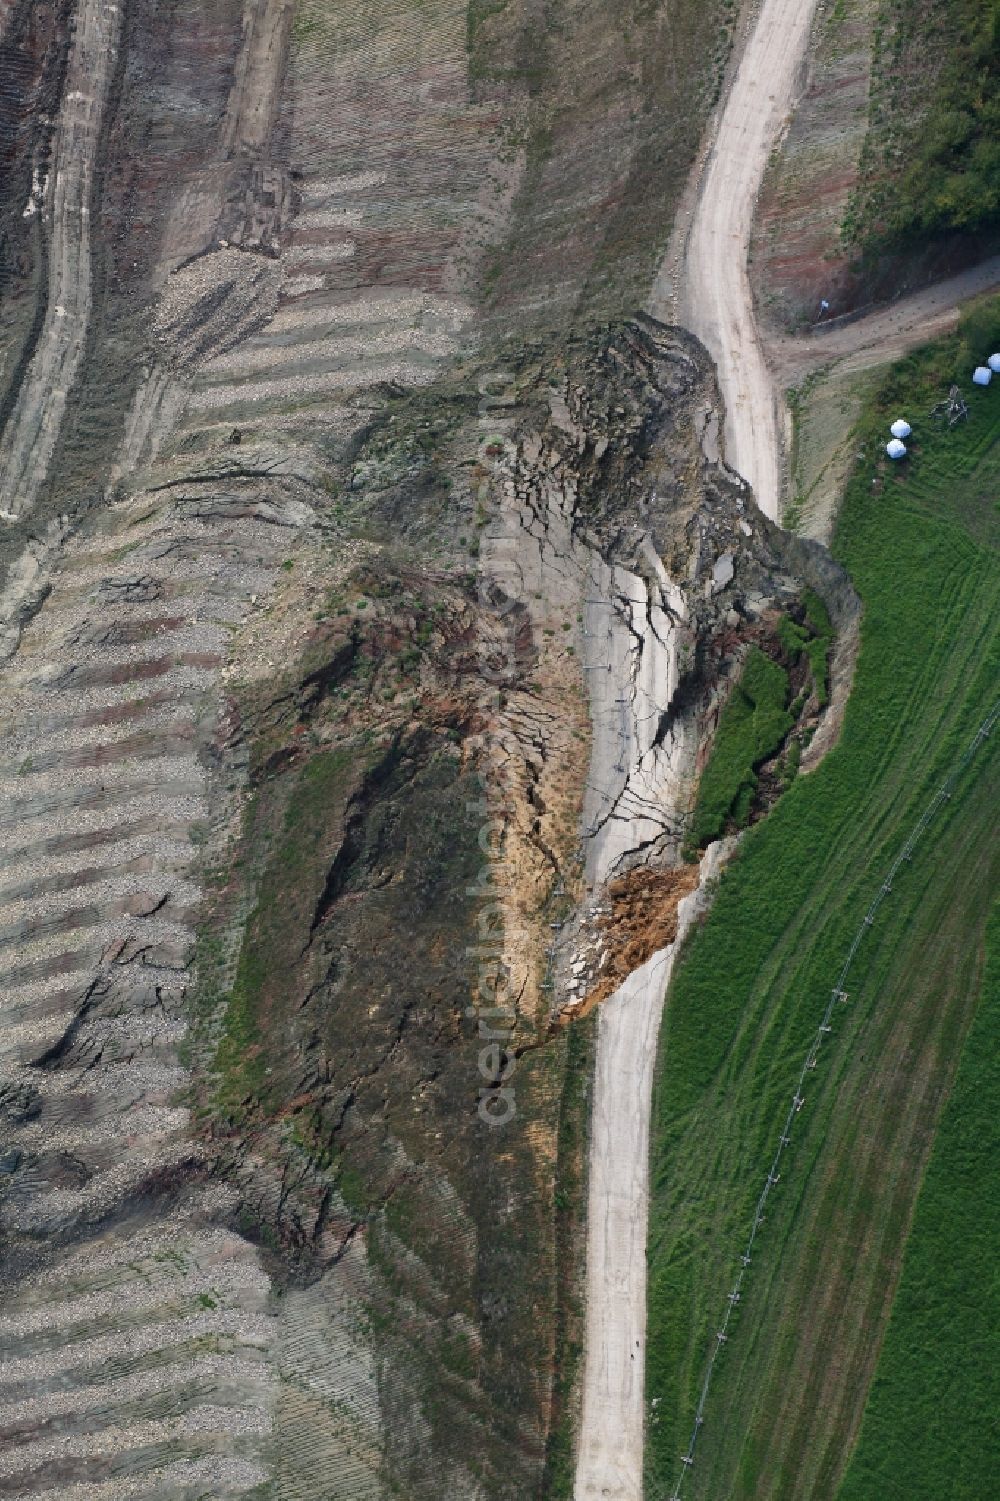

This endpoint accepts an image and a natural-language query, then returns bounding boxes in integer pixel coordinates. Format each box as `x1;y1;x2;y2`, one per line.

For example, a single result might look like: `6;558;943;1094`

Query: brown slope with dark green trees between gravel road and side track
754;0;1000;328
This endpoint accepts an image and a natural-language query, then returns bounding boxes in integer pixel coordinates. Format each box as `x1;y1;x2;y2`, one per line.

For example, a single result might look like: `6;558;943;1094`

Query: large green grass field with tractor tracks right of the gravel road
647;308;1000;1501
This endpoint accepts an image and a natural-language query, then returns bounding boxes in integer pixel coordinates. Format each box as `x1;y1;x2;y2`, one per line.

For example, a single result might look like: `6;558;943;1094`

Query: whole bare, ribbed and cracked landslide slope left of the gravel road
0;0;851;1501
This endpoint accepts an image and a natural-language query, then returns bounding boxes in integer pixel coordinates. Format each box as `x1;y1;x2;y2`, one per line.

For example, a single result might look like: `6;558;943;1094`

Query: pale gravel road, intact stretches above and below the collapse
575;0;815;1501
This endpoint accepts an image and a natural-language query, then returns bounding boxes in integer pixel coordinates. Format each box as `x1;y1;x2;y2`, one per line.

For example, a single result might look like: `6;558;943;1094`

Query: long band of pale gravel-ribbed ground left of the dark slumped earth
0;5;516;1501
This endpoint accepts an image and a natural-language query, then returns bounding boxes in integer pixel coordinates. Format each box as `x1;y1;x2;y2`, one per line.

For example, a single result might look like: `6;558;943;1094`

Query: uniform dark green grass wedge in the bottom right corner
838;907;1000;1501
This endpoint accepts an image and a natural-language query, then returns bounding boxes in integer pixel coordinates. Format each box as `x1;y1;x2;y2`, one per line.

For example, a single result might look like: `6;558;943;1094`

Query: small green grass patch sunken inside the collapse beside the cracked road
689;647;793;850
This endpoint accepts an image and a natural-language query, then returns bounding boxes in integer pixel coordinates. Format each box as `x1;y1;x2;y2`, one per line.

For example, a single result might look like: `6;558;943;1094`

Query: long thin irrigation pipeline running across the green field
657;701;1000;1501
